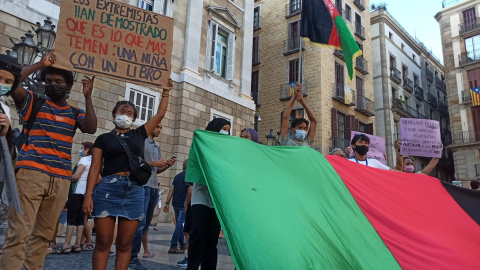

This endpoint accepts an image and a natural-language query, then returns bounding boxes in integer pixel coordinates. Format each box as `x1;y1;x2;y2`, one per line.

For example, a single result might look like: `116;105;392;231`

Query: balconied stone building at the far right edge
435;0;480;187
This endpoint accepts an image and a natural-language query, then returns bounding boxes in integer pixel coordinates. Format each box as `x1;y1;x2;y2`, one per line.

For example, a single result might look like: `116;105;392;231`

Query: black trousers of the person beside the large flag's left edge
187;204;220;270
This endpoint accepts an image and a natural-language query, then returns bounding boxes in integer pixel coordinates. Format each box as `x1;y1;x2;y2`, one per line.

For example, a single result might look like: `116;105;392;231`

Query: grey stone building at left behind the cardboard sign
0;0;255;220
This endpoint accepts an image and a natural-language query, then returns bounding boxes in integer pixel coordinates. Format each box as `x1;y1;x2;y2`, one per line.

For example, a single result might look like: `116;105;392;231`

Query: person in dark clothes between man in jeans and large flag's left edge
163;159;189;254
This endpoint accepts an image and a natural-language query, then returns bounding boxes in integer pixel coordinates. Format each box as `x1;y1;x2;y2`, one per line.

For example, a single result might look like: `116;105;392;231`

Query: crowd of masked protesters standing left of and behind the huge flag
0;49;479;270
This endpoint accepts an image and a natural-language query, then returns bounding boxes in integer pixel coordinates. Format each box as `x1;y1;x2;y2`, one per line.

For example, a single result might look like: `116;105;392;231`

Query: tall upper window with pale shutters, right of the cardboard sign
206;20;235;80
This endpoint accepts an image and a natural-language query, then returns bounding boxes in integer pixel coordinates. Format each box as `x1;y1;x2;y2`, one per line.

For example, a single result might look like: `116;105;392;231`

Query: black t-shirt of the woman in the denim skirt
93;126;148;176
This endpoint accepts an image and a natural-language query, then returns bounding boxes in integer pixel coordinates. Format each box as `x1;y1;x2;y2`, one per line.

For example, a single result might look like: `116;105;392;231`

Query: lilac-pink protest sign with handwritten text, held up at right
400;118;442;158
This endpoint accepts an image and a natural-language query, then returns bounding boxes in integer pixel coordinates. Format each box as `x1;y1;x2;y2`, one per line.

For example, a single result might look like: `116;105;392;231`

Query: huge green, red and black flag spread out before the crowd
186;130;480;270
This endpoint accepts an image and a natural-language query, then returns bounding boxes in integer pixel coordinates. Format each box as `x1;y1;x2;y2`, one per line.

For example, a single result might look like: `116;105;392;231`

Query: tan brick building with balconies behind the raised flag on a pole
252;0;375;154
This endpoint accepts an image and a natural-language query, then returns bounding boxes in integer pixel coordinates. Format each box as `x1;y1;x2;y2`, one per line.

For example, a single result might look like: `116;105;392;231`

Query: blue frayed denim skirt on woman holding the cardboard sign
92;175;145;220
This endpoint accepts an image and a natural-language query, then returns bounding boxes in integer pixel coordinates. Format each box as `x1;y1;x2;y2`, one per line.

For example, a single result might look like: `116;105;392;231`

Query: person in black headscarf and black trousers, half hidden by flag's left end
187;118;231;270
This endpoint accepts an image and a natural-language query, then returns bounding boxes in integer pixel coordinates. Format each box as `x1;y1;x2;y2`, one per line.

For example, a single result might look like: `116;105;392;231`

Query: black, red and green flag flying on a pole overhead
300;0;362;80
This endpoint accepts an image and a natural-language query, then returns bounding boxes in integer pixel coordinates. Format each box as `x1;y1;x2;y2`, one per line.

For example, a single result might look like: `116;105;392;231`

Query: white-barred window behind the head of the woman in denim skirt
125;83;160;125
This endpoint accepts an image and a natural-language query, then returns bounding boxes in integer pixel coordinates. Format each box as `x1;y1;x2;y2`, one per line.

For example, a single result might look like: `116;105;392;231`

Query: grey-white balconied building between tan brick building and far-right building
371;6;454;181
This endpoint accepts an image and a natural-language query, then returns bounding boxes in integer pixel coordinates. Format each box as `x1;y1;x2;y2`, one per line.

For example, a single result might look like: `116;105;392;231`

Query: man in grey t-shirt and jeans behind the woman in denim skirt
128;123;176;270
